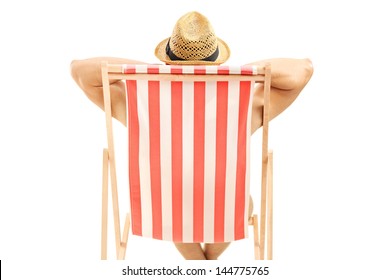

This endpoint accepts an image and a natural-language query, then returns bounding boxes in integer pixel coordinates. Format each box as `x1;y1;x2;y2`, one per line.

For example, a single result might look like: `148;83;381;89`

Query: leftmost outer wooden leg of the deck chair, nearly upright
101;149;108;260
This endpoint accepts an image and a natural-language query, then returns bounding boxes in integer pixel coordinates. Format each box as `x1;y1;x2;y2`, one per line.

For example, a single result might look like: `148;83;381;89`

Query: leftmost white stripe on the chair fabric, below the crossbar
137;80;153;237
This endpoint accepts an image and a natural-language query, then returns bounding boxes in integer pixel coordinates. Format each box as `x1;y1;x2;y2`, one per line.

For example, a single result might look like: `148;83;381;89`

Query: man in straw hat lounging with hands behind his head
71;12;313;260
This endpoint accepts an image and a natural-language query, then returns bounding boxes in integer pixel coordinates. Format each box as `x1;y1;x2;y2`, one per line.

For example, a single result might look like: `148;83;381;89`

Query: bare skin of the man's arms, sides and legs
71;57;313;260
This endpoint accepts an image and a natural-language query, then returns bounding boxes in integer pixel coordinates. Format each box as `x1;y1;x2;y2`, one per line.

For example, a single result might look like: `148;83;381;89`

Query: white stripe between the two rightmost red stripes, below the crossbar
225;81;240;240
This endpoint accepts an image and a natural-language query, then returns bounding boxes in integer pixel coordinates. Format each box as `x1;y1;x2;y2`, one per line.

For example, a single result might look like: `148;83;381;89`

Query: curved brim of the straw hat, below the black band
154;38;230;65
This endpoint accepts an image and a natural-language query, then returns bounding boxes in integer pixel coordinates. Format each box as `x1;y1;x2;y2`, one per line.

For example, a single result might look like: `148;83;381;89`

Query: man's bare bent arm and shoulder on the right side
249;58;313;133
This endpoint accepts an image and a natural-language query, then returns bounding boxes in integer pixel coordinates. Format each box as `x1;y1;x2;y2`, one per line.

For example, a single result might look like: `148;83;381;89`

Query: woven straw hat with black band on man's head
154;12;230;65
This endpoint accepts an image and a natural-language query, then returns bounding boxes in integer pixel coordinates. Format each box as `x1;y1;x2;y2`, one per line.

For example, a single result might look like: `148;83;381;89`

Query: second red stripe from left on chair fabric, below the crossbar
148;81;162;239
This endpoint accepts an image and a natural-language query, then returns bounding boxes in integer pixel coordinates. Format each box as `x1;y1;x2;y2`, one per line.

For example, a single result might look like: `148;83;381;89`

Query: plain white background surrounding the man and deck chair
0;0;390;279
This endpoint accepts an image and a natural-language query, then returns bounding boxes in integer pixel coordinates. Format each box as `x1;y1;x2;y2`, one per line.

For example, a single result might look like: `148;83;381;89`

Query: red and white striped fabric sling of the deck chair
123;65;256;243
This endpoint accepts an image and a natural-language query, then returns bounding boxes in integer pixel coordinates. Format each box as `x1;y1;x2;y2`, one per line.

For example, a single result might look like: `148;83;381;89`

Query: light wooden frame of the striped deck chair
101;62;273;260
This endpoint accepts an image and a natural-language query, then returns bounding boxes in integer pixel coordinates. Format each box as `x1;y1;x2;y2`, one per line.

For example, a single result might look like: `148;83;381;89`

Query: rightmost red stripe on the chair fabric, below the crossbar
234;81;251;240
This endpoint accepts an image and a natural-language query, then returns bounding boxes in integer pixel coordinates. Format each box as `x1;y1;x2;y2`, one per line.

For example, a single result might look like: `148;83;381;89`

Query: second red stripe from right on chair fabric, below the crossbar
214;82;228;242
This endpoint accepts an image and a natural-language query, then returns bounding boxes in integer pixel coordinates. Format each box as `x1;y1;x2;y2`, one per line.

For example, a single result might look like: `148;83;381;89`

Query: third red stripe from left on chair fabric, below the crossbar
171;82;183;242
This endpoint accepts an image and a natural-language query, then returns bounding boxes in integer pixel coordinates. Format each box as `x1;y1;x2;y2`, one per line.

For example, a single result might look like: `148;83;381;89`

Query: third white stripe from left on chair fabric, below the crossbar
183;82;194;242
